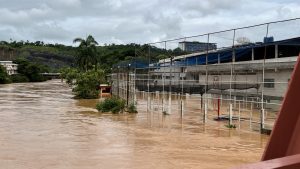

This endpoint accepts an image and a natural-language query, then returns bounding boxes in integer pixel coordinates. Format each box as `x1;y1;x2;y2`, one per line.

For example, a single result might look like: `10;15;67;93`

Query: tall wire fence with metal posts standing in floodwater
111;18;300;131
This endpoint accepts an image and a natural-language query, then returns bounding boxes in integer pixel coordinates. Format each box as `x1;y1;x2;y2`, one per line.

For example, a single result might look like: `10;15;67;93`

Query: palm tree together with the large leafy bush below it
60;35;105;99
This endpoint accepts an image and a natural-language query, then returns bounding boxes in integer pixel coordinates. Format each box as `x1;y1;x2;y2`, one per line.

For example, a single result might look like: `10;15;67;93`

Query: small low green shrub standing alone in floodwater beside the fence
96;97;125;113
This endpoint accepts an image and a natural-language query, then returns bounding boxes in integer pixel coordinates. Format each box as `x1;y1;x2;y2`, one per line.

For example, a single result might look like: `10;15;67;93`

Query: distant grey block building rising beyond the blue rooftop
178;41;217;52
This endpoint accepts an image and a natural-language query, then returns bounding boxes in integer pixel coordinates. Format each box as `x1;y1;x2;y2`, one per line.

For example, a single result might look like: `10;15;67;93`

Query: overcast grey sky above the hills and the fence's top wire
0;0;300;45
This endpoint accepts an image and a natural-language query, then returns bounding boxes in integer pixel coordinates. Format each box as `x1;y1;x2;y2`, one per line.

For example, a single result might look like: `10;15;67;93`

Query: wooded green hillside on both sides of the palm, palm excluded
0;41;188;72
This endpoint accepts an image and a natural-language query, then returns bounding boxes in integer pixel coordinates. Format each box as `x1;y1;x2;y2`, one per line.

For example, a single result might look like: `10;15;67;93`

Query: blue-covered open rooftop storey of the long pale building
159;37;300;66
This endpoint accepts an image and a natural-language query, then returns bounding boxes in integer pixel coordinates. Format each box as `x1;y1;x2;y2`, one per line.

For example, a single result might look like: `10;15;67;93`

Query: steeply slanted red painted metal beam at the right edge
262;57;300;161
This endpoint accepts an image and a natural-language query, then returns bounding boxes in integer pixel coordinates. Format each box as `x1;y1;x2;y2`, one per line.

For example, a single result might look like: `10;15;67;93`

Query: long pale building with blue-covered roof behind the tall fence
142;37;300;110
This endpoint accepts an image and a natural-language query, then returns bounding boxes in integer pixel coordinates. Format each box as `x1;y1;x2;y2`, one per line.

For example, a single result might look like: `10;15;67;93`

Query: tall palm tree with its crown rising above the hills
73;35;98;71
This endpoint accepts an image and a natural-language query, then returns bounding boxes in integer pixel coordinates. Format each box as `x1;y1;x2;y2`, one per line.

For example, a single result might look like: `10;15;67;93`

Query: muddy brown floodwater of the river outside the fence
0;80;268;169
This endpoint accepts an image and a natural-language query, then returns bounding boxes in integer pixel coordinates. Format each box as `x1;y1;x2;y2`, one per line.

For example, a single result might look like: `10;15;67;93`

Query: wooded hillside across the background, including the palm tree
0;35;186;73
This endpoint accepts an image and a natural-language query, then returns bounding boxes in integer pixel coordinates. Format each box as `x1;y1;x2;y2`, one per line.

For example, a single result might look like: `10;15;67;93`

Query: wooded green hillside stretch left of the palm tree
0;41;76;72
